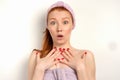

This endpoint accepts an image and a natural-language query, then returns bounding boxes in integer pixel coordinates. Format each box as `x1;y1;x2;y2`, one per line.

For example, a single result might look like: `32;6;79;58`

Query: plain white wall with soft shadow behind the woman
0;0;120;80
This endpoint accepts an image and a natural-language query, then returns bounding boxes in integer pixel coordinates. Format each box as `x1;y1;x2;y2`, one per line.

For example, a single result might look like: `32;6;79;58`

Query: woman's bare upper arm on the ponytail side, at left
28;49;39;80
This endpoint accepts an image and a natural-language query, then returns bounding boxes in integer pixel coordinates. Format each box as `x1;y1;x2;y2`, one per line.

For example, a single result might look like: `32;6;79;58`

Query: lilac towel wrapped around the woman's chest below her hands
44;68;77;80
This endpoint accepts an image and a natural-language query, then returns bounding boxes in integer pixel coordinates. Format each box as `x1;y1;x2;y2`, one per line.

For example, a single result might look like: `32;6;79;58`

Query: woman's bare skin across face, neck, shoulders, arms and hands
28;10;95;80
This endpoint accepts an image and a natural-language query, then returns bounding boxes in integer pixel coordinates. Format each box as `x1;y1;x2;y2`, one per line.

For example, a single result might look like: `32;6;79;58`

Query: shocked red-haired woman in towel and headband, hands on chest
28;1;95;80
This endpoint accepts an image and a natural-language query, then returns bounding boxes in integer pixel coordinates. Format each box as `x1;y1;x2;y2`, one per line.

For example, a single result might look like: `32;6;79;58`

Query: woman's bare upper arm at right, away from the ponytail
85;51;96;80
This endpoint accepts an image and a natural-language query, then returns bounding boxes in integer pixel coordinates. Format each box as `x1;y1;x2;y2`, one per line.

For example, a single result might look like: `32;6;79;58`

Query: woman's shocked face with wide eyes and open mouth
47;10;73;44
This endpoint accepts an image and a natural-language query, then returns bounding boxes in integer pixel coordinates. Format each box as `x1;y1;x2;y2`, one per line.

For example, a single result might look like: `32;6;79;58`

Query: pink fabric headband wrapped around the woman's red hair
47;1;75;28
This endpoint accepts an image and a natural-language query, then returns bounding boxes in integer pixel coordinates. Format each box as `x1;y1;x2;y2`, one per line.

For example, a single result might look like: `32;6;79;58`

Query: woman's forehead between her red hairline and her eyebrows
48;9;72;19
